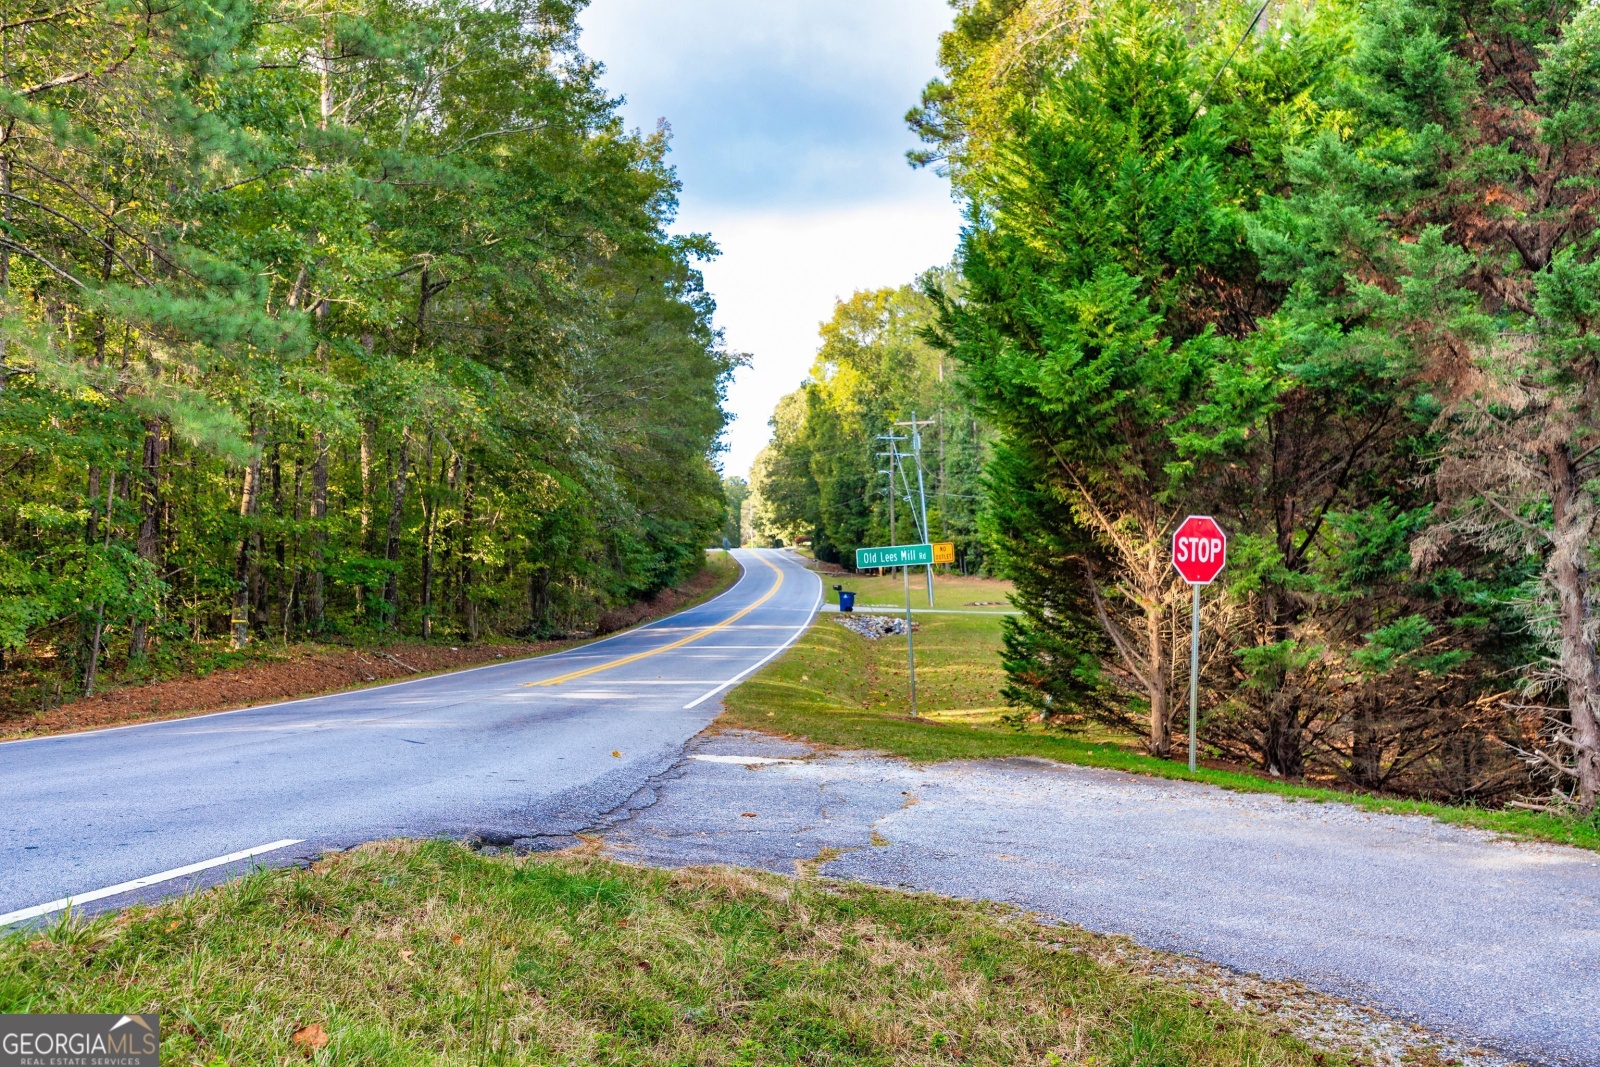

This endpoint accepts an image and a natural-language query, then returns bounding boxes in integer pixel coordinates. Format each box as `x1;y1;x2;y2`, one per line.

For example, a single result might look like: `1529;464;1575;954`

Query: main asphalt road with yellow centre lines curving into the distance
0;549;822;925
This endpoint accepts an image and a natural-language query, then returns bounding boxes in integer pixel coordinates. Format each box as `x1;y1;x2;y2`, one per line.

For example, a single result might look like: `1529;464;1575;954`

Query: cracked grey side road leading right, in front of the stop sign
606;734;1600;1065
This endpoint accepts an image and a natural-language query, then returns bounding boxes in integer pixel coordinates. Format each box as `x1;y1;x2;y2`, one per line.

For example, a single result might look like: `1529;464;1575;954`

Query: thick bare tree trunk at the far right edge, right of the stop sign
1544;442;1600;811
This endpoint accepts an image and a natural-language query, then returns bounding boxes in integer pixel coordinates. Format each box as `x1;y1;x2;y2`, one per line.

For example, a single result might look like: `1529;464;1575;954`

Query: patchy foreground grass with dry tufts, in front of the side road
0;841;1349;1067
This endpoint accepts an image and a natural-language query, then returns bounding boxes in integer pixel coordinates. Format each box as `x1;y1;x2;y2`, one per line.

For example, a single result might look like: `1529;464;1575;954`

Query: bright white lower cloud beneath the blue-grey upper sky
685;194;962;475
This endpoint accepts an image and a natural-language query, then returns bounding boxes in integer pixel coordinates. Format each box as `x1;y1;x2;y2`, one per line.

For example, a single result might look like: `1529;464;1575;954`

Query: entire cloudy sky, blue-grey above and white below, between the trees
581;0;962;475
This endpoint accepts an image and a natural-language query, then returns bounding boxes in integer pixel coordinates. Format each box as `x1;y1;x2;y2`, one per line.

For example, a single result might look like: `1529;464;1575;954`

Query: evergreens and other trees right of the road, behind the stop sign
749;0;1600;813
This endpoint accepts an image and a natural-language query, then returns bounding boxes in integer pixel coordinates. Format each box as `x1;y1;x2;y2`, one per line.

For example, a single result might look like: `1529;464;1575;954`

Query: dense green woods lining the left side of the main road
0;0;742;691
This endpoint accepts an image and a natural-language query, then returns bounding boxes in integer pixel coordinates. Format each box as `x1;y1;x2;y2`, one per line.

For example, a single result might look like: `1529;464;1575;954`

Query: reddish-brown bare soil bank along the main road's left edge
0;568;738;741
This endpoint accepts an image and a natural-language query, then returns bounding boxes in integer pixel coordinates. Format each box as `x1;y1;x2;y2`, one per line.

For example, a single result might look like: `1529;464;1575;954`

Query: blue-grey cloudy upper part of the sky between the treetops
581;0;950;208
